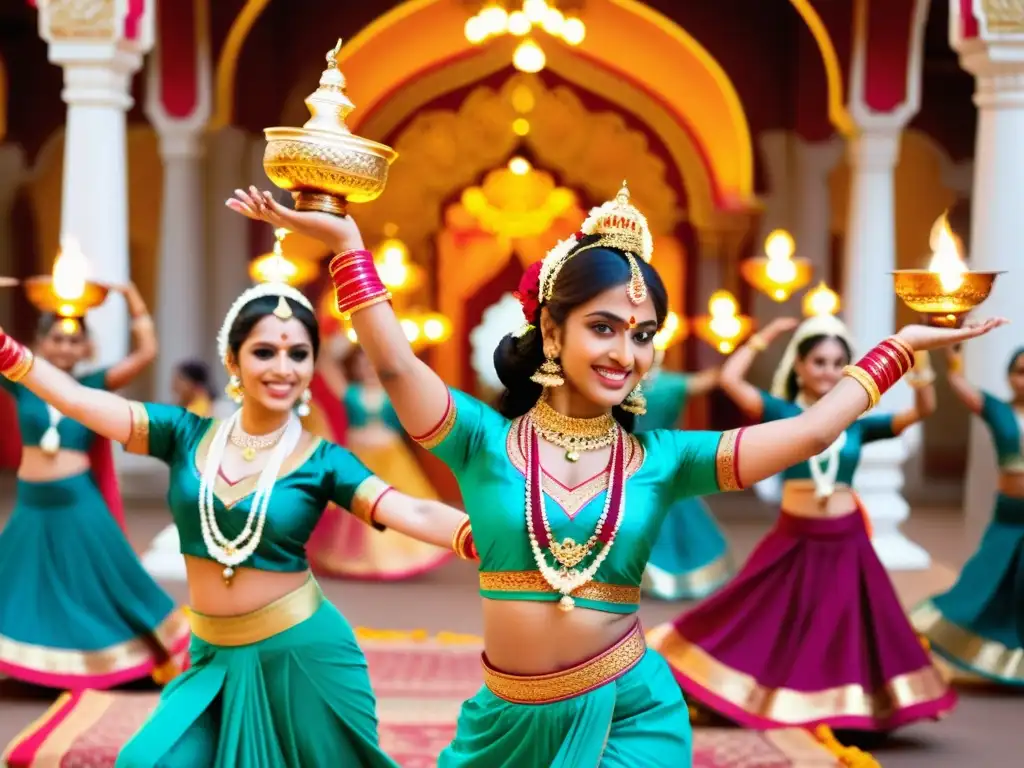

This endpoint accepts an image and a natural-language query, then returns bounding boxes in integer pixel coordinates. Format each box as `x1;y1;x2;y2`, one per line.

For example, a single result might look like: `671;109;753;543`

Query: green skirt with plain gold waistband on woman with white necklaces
116;583;397;768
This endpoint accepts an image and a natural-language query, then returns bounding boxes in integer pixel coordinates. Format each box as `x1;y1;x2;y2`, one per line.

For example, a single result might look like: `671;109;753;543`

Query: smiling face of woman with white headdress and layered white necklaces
229;314;313;412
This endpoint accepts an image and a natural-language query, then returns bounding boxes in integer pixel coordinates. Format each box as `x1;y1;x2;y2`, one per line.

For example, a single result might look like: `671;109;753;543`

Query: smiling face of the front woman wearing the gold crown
542;286;657;409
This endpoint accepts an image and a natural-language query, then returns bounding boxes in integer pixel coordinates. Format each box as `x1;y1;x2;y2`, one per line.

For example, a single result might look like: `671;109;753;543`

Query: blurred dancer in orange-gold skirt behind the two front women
306;347;453;582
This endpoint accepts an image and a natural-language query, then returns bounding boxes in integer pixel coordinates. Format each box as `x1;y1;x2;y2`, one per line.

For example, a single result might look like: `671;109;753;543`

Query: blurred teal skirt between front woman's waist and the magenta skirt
640;499;734;600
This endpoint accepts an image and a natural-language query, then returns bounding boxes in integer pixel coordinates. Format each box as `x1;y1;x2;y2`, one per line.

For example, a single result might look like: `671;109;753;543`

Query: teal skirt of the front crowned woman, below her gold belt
437;650;693;768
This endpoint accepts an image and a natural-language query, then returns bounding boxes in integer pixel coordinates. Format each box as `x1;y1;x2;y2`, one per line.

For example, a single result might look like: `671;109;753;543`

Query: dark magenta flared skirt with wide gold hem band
648;511;956;731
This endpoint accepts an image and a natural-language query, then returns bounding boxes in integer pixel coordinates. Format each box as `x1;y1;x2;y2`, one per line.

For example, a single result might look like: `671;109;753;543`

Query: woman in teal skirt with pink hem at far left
0;285;188;690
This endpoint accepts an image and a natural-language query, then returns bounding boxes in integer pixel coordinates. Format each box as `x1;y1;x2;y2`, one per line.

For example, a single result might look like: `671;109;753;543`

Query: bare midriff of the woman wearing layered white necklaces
184;555;309;616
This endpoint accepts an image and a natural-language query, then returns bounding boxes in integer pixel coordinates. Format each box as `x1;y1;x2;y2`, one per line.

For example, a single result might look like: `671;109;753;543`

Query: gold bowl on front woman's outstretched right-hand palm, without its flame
893;269;1002;328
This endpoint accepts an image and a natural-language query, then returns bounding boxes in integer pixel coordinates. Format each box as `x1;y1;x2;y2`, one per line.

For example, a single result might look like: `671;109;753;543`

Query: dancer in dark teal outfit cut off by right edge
910;348;1024;687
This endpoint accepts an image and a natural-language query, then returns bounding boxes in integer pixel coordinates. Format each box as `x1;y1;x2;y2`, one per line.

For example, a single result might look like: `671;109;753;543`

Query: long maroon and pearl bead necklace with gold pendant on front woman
526;422;626;610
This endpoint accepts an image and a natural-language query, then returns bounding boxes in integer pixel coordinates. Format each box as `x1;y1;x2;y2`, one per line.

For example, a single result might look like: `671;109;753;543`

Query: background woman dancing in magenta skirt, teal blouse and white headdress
652;314;956;731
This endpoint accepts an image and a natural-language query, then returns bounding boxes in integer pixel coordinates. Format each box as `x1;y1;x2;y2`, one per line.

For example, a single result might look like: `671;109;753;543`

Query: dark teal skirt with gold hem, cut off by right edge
910;494;1024;686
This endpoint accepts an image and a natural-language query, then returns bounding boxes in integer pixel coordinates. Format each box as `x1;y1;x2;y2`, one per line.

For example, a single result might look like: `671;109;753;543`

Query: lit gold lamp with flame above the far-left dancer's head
25;238;110;333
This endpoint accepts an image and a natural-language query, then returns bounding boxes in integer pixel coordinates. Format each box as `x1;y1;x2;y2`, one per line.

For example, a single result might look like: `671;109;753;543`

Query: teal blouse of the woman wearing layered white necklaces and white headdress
125;402;390;571
